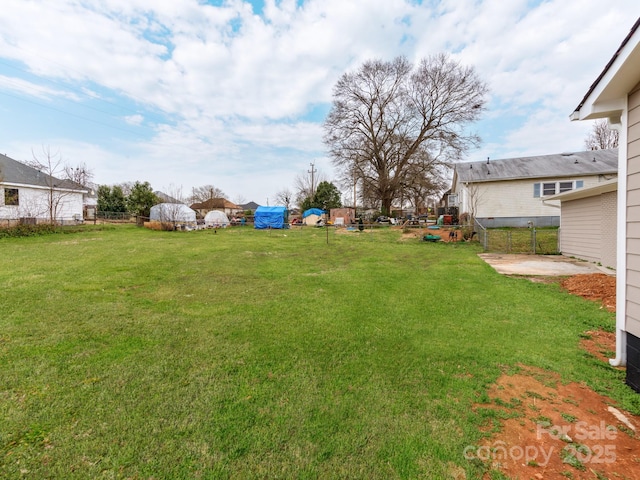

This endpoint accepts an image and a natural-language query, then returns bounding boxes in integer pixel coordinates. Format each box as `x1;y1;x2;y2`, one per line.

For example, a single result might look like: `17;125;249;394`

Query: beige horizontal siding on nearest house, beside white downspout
626;85;640;337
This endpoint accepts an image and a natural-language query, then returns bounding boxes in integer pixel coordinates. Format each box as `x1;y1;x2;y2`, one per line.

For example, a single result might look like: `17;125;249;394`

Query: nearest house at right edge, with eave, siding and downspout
571;19;640;392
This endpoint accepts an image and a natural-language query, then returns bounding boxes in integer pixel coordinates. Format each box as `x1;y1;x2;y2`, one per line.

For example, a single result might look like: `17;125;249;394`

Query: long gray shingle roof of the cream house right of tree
454;148;618;183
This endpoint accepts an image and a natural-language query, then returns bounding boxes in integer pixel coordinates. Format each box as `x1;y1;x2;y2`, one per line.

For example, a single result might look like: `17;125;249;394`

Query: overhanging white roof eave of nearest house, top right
570;18;640;120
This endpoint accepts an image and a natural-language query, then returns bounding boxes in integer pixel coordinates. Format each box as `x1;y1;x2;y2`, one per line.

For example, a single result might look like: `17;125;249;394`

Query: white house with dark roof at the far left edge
0;154;88;225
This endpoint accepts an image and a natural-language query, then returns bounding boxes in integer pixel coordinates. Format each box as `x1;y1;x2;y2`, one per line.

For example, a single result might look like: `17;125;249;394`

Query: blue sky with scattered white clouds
0;0;640;204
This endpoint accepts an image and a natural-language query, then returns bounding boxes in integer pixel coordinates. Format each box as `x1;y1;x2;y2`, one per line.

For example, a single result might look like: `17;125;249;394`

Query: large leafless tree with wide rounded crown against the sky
324;55;487;214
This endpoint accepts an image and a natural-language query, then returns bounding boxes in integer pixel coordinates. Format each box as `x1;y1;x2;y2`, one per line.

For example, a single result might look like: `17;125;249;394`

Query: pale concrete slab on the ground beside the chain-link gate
478;253;615;276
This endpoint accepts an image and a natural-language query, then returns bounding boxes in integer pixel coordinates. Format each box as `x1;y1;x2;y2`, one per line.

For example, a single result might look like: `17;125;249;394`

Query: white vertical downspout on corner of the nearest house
608;112;629;367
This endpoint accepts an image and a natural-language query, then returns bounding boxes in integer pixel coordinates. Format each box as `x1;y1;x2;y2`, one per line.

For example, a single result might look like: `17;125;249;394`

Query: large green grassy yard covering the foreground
0;227;640;479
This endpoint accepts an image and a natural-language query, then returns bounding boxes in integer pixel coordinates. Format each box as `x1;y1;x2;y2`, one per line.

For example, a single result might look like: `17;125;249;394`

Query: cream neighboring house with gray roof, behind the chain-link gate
449;150;618;227
